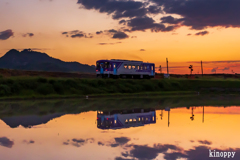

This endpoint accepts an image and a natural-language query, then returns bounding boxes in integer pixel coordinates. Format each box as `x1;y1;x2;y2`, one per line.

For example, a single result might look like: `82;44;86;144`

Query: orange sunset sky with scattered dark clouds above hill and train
0;0;240;74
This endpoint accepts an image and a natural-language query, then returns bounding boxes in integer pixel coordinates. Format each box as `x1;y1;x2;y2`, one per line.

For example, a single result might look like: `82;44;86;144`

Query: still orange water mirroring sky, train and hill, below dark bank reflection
0;98;240;160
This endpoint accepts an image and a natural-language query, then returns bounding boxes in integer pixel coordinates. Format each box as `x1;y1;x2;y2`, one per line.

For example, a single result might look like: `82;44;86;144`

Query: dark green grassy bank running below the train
0;77;240;99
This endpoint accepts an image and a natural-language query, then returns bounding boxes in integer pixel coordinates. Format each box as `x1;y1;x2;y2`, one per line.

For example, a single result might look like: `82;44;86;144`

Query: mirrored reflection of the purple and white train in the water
97;108;156;129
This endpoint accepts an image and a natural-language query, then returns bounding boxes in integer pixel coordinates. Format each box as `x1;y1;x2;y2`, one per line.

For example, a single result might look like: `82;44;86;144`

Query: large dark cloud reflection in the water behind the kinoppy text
117;141;240;160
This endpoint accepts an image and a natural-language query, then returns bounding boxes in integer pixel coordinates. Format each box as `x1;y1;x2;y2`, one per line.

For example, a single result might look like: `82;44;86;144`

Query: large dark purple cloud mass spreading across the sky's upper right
77;0;240;32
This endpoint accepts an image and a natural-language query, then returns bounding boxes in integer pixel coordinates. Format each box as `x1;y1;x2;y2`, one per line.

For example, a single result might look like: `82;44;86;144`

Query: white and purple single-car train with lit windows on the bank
96;59;155;79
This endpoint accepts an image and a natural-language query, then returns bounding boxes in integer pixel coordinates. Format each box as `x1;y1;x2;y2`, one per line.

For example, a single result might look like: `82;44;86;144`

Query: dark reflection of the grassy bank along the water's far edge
0;95;240;118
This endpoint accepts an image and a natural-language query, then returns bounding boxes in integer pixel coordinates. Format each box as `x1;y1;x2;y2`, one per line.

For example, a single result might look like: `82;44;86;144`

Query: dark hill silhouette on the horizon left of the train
0;49;95;73
